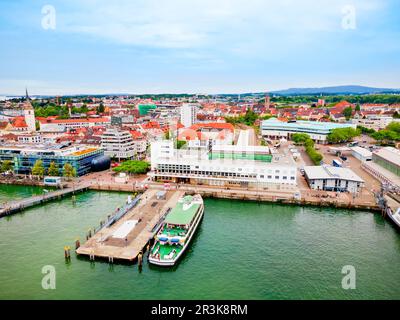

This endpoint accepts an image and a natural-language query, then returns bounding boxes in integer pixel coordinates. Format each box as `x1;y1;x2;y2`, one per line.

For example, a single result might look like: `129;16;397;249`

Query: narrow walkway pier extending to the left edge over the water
0;183;90;218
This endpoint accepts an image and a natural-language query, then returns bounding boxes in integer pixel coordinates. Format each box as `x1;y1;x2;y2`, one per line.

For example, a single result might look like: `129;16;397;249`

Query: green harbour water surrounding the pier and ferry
0;186;400;299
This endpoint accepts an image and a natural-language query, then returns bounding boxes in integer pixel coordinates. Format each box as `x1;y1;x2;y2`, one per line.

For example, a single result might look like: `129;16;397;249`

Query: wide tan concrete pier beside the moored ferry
76;189;185;262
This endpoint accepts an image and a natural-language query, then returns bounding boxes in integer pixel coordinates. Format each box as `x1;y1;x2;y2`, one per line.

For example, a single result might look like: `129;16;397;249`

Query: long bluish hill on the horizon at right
270;85;400;95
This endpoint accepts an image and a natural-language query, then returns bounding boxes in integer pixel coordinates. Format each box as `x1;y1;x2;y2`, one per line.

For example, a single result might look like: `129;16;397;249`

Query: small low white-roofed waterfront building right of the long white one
304;165;364;193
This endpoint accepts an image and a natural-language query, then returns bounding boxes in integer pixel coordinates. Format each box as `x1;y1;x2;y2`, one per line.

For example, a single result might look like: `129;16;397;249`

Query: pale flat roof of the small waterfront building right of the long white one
304;166;364;182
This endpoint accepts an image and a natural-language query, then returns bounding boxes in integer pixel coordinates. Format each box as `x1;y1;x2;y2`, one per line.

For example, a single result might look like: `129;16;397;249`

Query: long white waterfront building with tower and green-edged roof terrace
149;140;297;190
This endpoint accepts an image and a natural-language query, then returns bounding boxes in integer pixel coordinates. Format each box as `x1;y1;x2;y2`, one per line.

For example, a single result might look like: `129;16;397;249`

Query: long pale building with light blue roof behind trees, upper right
261;118;356;144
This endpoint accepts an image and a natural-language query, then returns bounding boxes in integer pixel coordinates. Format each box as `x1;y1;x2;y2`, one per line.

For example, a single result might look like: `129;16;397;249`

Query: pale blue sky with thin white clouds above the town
0;0;400;95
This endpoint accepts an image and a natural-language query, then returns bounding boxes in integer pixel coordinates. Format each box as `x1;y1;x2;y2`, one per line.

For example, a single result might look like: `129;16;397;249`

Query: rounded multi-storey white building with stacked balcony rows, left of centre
101;128;137;159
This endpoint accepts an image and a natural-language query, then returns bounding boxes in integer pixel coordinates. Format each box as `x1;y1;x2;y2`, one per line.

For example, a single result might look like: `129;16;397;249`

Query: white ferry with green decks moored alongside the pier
148;194;204;266
